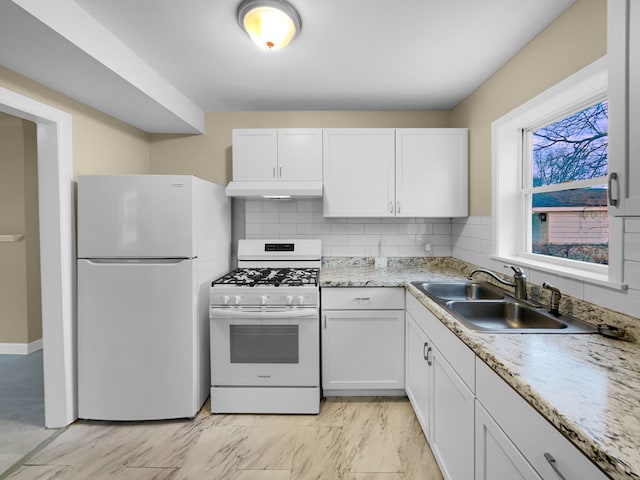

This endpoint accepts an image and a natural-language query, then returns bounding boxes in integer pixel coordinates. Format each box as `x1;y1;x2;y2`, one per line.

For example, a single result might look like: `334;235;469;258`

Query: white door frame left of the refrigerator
0;87;78;428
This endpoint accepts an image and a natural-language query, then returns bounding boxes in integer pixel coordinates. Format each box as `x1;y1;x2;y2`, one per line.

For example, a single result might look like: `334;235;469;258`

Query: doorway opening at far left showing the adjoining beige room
0;112;52;474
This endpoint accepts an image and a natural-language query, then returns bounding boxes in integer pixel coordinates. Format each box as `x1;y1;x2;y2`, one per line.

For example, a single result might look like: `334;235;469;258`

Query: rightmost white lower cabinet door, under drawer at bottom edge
475;401;541;480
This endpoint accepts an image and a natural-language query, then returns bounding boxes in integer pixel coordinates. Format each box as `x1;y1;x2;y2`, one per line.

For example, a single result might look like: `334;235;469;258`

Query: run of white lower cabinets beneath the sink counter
405;293;608;480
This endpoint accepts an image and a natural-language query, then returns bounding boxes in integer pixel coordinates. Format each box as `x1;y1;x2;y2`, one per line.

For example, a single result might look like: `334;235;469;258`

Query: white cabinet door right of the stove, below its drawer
322;310;404;390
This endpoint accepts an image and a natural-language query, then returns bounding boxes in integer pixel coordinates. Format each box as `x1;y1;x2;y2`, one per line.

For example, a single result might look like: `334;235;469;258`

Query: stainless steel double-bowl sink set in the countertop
413;282;596;333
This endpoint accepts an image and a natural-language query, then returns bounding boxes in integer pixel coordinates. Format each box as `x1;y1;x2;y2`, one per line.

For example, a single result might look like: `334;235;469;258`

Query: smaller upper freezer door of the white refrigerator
78;175;196;258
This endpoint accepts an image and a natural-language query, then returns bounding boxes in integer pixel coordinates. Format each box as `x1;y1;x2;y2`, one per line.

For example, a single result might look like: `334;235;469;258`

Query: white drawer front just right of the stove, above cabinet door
322;287;404;310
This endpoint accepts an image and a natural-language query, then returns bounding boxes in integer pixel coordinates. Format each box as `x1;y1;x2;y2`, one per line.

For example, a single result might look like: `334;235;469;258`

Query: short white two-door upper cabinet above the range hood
233;128;322;182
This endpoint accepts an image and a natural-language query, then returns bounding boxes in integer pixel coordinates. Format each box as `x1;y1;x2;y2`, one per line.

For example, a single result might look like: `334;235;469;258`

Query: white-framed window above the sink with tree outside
492;58;624;288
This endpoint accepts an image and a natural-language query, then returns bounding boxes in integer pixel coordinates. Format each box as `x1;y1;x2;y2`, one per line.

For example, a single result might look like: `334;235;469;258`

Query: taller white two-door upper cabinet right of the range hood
323;128;468;217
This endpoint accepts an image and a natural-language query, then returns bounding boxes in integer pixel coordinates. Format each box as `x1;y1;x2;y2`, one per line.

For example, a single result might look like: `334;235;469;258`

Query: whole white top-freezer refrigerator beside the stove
77;175;231;420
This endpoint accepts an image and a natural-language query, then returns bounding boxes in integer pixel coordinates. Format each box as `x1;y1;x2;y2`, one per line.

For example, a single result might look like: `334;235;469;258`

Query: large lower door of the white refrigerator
78;260;201;420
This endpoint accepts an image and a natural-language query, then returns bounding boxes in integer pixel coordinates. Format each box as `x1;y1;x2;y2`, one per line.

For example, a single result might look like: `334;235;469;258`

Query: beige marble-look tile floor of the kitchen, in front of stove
8;397;442;480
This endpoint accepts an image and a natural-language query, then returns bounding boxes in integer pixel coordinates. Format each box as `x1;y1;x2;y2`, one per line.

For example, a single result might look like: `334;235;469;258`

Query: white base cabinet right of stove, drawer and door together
321;288;404;395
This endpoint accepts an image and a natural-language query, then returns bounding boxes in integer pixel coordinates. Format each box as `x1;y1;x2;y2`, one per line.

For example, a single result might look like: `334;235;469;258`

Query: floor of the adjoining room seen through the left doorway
0;350;56;478
